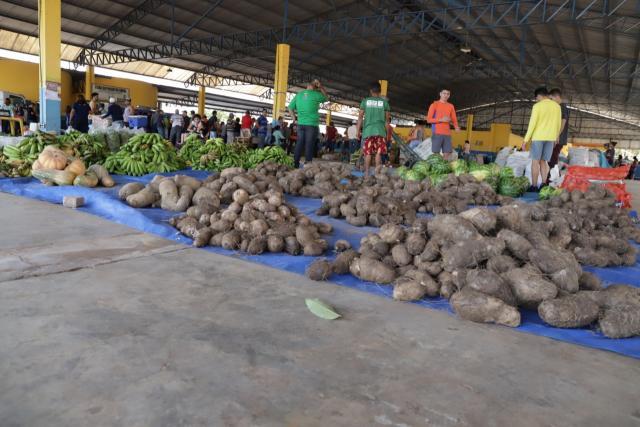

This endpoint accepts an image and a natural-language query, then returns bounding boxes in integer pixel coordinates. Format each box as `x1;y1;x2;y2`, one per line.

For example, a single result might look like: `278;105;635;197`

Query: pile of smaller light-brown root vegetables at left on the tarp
119;163;332;256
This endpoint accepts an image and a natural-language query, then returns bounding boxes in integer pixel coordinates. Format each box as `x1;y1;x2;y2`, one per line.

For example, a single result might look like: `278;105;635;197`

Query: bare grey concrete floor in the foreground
0;194;640;427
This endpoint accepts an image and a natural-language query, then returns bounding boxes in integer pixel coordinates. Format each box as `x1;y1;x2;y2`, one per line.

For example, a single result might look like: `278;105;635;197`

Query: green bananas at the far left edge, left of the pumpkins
0;131;57;177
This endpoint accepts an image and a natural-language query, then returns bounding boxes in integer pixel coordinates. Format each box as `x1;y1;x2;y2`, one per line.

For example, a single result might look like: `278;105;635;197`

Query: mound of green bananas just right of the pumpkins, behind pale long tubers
104;133;185;176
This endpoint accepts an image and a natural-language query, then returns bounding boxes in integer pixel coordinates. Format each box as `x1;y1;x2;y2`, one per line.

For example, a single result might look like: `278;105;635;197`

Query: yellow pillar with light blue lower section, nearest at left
38;0;62;132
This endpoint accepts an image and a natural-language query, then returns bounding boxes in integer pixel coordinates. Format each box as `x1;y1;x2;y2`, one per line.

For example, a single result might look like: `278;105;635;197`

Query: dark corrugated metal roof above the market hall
0;0;640;129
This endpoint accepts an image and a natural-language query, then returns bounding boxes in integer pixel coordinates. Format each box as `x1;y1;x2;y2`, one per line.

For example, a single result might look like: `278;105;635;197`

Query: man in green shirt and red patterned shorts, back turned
357;82;391;176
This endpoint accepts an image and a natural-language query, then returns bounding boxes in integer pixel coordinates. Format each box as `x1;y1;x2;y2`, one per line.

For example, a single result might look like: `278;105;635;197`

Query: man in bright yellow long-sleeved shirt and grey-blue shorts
522;87;562;191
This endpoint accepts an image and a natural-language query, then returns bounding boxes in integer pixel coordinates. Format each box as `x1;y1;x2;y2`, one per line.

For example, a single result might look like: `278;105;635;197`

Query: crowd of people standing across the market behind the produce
0;80;638;182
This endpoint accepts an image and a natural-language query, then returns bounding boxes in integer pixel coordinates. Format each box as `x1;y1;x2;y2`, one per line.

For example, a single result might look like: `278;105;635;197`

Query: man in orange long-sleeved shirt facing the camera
427;89;460;160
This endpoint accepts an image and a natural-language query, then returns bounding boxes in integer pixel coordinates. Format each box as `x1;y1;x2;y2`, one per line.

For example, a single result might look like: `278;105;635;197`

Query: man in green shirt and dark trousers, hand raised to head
289;79;328;168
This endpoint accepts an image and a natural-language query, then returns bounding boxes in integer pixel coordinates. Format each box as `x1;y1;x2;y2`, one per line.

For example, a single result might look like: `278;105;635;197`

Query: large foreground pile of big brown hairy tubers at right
307;186;640;338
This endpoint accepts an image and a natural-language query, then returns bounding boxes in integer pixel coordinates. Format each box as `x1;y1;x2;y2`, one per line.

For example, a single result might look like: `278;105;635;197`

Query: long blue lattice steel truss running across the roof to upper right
82;0;640;65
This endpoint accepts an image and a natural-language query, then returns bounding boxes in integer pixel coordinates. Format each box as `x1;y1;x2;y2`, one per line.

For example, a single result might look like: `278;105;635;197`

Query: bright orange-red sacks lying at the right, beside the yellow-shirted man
560;165;631;208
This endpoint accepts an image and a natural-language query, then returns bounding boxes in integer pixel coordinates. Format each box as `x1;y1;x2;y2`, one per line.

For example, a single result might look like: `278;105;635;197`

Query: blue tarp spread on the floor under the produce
0;170;640;359
